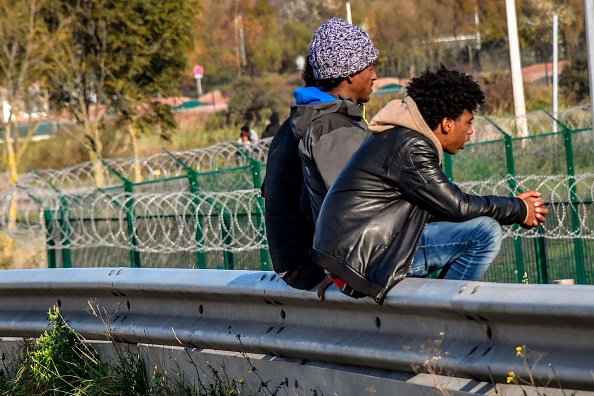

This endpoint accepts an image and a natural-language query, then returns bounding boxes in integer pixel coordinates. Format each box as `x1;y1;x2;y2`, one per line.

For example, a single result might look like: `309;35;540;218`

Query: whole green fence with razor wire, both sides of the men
0;108;594;284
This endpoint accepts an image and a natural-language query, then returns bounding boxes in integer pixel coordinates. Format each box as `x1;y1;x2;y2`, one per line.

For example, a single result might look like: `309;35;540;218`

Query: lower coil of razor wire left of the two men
0;189;266;253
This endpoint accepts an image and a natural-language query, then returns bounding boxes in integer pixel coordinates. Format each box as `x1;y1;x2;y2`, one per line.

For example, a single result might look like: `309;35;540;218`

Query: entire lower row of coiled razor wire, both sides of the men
0;174;594;253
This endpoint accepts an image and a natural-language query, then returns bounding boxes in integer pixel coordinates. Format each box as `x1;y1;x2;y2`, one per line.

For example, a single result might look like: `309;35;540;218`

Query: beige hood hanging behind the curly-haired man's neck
369;96;443;163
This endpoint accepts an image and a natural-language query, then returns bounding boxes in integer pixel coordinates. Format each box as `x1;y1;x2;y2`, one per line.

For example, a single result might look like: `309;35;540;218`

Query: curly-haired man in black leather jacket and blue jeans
313;65;548;304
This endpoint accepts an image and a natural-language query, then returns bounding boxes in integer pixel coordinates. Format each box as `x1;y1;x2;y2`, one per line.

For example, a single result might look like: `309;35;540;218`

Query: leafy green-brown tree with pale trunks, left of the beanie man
47;0;193;187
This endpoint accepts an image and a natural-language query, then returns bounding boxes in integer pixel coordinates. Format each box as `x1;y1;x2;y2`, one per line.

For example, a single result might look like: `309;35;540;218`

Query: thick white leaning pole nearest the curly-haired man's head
505;0;524;137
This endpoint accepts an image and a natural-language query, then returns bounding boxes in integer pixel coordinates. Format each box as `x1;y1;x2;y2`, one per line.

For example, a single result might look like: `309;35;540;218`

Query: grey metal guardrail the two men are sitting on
0;268;594;390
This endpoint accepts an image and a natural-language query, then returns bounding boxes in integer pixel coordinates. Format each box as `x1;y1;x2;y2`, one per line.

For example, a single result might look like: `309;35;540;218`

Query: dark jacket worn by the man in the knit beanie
262;87;369;289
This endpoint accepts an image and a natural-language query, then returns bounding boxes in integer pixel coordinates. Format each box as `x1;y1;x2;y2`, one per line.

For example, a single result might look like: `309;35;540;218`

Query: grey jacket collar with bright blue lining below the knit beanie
291;87;363;139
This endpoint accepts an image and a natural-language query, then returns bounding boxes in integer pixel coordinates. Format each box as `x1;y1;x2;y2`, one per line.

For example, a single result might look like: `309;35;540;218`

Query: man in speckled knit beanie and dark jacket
263;18;379;289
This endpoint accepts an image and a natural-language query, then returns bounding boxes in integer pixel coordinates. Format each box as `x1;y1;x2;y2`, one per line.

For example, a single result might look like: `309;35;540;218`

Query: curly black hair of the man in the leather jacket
406;65;485;130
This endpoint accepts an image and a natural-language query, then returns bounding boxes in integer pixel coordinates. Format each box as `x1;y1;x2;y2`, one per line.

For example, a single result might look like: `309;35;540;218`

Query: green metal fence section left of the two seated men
36;147;272;270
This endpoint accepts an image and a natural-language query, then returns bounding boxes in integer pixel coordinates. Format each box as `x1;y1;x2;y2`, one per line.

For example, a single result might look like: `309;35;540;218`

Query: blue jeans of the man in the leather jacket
407;217;502;280
